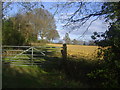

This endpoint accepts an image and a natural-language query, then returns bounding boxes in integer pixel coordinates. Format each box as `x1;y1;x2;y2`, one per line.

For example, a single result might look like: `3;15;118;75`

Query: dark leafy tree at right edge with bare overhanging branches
51;1;120;87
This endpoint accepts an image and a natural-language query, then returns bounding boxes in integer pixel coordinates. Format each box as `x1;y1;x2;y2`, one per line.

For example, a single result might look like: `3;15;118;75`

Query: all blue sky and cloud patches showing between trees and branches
3;2;108;41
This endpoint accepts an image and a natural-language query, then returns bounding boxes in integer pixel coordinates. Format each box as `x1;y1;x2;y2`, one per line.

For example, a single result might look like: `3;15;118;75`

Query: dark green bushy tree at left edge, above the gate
2;19;25;45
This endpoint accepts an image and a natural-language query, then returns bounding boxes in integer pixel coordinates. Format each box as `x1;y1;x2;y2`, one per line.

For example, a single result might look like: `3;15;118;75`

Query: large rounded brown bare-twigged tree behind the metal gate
2;8;59;45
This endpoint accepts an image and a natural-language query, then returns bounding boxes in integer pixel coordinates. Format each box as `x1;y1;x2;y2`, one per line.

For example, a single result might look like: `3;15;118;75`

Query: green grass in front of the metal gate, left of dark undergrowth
3;62;83;88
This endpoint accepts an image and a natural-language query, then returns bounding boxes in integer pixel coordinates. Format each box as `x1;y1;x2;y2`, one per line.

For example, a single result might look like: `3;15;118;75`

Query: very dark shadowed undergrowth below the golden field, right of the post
64;58;101;88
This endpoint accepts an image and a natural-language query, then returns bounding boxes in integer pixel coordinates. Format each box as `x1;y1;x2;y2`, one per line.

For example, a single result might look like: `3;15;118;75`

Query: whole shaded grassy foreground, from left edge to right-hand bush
3;51;102;88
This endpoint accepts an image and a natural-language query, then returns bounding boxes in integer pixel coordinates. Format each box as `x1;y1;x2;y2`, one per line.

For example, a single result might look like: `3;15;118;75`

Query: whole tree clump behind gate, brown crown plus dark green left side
3;8;59;45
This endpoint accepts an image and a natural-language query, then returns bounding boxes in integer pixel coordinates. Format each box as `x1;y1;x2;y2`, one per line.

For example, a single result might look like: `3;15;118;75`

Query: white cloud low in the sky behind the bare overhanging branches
55;8;108;39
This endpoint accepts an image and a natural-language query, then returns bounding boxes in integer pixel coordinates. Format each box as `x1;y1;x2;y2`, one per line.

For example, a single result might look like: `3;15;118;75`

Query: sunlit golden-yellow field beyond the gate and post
48;44;98;59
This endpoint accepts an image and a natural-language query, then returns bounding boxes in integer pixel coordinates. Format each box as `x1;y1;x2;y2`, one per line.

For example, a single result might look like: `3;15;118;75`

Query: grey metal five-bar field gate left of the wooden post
2;46;63;65
